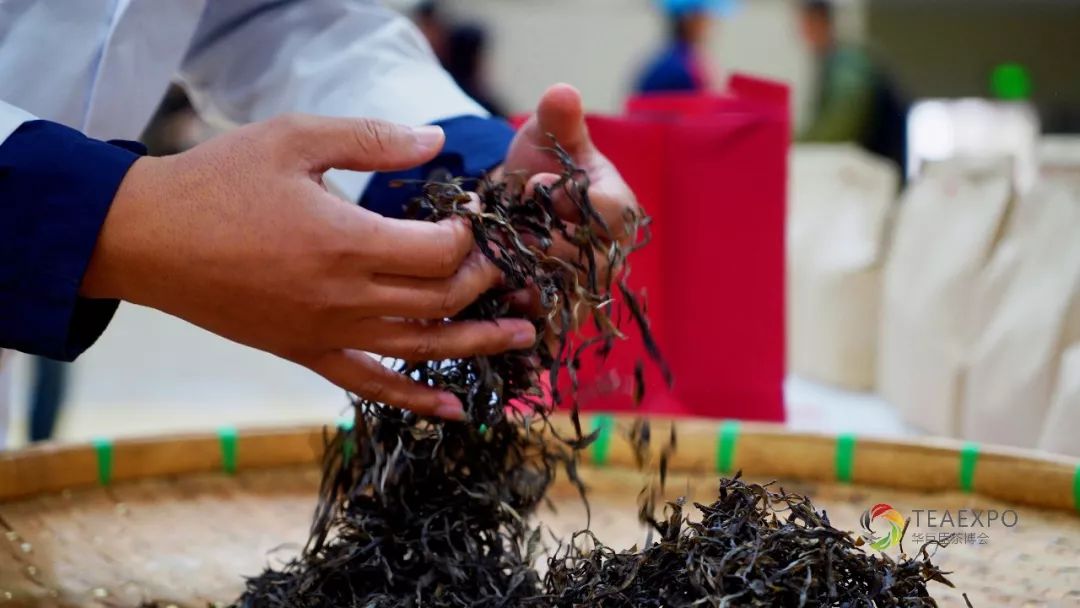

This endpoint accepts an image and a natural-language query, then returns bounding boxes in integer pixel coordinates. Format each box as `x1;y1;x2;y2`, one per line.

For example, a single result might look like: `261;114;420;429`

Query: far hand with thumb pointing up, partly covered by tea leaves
500;84;640;307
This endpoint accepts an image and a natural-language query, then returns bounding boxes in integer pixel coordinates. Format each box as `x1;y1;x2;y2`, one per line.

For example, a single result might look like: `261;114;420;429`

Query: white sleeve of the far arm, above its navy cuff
180;0;488;201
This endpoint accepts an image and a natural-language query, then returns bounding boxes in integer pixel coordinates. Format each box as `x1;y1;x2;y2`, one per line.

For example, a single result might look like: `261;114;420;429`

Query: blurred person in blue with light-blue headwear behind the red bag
634;0;731;93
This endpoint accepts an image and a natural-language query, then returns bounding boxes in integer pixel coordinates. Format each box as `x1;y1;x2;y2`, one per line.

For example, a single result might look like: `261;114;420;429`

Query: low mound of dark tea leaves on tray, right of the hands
536;475;967;608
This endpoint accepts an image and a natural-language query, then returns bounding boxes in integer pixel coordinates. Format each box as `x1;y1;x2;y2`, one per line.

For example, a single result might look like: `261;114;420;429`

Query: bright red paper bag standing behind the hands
535;77;789;421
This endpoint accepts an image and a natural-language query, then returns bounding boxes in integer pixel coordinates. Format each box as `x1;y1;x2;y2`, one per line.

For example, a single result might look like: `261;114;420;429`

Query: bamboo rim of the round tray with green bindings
0;414;1080;513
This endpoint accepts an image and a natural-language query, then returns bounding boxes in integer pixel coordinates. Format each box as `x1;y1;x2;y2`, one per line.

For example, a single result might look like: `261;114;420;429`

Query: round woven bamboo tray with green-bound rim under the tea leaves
0;416;1080;606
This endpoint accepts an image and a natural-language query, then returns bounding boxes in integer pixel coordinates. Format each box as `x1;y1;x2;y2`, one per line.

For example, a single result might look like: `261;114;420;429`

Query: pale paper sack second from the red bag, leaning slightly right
877;154;1014;435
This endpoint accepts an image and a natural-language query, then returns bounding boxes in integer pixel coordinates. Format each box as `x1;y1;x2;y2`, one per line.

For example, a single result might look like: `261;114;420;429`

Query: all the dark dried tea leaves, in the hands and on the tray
238;144;947;608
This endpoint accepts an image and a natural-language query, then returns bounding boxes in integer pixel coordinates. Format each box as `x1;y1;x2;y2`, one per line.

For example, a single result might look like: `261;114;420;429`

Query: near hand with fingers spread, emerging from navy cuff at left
80;116;536;419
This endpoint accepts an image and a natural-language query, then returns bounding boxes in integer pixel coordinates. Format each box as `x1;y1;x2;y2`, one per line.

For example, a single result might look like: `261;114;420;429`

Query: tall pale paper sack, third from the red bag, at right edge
962;140;1080;447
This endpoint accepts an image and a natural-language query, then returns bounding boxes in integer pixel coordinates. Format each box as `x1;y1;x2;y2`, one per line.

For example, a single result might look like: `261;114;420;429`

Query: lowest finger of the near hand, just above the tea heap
300;350;465;420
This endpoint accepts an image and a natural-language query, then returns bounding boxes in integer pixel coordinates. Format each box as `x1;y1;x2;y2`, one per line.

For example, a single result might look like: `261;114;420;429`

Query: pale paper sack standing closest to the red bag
787;145;900;390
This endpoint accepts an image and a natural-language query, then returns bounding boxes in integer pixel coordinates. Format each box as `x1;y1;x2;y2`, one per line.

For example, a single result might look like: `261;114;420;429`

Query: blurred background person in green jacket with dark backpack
800;0;907;168
